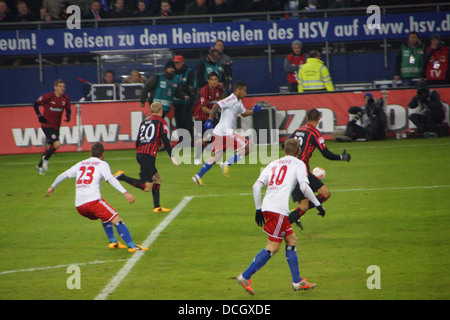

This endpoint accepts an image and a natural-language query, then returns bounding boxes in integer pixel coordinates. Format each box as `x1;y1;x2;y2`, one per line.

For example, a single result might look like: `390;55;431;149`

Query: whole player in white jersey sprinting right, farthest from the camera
192;81;261;186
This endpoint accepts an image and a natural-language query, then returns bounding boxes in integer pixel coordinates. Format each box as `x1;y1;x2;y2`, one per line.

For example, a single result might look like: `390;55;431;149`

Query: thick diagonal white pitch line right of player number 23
95;197;193;300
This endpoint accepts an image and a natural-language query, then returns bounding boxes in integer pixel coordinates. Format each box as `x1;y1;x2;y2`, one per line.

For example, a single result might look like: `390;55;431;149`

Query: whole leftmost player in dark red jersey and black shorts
33;79;72;175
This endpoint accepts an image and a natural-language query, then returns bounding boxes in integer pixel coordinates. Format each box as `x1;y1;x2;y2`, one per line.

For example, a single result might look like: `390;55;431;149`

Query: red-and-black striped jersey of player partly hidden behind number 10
290;123;340;172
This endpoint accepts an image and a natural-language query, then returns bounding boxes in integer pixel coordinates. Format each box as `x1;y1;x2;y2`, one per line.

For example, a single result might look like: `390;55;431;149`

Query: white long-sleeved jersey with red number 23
52;157;126;207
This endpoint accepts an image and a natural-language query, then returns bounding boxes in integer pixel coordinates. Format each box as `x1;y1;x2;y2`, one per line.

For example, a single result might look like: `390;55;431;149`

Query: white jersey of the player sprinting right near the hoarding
213;94;246;136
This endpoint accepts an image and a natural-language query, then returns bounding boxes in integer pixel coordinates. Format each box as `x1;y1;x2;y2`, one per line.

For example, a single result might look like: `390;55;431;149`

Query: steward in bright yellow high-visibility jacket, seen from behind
297;50;334;92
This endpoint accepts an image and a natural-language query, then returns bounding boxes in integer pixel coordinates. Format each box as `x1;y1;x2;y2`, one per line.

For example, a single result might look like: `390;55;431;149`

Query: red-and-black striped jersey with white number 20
136;114;172;157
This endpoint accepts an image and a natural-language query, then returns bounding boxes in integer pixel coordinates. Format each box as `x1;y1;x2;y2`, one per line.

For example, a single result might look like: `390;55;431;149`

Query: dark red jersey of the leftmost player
34;92;71;130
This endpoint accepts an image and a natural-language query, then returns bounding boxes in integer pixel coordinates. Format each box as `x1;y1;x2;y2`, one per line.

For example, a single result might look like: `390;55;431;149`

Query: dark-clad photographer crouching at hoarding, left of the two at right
345;92;387;141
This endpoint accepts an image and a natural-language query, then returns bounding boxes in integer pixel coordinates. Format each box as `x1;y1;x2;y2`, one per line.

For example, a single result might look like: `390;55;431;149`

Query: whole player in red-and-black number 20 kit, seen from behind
114;102;178;212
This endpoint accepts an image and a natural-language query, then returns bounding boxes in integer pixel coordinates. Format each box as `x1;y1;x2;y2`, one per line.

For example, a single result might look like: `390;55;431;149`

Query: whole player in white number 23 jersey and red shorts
47;142;147;252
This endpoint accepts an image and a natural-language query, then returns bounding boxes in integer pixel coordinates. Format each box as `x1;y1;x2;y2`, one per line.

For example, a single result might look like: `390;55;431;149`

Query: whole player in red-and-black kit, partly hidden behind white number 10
289;109;351;229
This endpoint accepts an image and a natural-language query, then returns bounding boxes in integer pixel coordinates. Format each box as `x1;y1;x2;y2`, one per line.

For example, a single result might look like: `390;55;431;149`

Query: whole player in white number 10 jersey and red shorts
237;139;325;295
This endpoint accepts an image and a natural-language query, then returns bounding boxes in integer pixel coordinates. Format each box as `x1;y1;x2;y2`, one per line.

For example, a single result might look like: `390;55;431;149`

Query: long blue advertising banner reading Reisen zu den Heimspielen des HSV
0;11;450;55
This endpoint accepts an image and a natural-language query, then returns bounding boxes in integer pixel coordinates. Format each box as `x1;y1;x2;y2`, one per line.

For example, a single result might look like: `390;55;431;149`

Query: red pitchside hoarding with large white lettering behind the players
0;88;450;154
